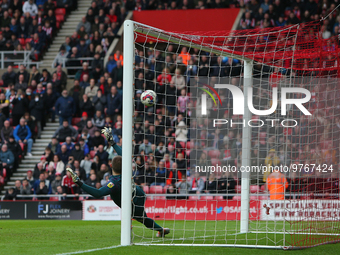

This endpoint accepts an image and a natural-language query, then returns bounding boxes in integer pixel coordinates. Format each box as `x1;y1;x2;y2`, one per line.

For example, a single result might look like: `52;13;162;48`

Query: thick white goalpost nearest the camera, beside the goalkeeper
120;20;134;246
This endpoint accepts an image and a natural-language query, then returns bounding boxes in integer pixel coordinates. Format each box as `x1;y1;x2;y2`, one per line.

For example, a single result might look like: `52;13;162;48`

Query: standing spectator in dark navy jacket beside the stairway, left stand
55;89;76;126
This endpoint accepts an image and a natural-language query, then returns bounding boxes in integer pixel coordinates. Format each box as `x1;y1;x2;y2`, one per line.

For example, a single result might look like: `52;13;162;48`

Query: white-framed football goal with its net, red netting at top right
122;21;340;249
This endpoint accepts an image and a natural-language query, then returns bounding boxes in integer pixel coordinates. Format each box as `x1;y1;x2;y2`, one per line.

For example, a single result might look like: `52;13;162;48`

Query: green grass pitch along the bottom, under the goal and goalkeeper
0;220;340;255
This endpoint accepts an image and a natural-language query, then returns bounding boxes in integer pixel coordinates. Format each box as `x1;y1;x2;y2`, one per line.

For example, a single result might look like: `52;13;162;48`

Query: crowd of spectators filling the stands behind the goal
0;0;340;199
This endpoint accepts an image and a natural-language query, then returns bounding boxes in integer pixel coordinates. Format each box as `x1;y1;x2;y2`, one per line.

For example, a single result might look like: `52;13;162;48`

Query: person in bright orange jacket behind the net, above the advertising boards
266;167;288;200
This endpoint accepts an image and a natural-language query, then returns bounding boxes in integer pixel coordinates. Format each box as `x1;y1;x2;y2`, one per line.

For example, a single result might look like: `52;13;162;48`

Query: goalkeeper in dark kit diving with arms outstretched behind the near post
66;127;170;237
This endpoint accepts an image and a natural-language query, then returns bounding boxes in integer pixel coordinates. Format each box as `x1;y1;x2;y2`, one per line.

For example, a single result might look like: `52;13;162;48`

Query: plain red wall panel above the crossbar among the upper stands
133;8;240;32
